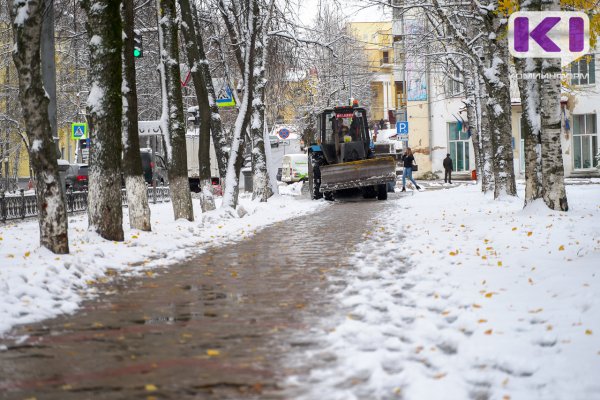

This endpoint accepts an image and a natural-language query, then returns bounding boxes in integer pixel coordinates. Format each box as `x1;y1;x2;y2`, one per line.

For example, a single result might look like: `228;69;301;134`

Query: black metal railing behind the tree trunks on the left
0;186;171;222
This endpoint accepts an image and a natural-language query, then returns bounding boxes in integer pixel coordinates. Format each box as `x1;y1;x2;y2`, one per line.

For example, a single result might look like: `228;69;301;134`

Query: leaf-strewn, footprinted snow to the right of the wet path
288;185;600;400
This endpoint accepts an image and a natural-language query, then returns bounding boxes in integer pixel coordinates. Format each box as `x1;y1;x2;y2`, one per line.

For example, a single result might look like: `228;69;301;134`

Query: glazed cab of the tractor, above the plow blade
318;107;371;164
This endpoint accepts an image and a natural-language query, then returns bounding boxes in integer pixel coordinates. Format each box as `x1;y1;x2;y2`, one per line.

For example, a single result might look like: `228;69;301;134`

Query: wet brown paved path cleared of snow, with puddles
0;195;391;400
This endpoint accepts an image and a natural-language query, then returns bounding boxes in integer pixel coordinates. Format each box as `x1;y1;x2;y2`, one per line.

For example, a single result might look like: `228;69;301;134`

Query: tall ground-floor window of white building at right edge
573;114;598;169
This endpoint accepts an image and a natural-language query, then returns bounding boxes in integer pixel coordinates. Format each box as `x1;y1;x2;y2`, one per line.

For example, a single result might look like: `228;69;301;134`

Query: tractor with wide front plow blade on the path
308;106;396;200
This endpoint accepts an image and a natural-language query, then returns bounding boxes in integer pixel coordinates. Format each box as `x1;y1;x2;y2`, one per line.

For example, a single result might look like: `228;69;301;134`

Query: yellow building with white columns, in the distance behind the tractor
348;21;405;121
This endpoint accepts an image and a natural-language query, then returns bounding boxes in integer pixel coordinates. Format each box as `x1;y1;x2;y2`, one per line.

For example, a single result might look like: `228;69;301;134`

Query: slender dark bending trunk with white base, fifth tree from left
179;0;215;212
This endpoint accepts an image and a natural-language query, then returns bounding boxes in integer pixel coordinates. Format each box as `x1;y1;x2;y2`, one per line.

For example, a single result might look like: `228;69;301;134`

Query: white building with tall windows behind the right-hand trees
424;54;600;179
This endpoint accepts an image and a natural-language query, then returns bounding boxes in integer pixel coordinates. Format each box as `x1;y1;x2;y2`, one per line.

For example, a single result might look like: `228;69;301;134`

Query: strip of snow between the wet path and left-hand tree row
0;189;326;336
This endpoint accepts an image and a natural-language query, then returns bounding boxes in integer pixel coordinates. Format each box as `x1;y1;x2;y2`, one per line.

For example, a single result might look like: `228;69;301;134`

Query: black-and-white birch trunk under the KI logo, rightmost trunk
540;0;569;211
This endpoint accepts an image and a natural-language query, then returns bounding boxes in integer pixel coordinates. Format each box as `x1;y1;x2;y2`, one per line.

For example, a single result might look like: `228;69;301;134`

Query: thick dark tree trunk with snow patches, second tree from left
81;0;123;241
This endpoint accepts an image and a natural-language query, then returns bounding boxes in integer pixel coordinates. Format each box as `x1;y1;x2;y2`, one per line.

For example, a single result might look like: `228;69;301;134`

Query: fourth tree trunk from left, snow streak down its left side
158;0;194;221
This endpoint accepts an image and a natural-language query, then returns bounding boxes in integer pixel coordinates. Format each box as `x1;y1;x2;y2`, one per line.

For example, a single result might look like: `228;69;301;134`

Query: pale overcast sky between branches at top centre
295;0;391;24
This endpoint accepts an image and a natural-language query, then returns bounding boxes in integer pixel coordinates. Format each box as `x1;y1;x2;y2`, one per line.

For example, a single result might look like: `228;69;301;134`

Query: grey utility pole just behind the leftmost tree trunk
40;0;61;158
